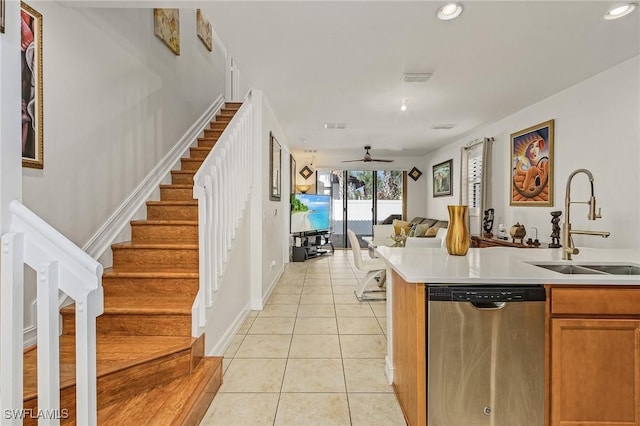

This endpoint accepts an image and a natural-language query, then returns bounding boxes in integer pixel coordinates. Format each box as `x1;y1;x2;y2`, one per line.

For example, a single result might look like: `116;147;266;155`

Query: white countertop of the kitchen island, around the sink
376;247;640;285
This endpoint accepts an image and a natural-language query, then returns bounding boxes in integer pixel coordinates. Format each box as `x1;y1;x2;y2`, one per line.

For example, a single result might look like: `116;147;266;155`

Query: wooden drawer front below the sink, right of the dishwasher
551;287;640;315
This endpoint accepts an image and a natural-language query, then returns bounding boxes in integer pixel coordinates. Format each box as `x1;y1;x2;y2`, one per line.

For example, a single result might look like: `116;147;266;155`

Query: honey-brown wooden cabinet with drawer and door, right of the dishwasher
547;287;640;426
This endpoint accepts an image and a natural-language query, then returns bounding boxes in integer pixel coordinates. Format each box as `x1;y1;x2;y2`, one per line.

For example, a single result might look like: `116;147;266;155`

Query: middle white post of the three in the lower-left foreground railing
37;261;60;425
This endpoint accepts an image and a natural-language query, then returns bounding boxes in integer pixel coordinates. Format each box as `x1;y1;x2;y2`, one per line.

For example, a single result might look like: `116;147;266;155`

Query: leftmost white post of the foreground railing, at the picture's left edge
0;232;24;426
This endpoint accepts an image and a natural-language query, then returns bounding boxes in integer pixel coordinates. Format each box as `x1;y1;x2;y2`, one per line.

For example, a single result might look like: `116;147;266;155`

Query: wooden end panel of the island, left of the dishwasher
392;271;427;426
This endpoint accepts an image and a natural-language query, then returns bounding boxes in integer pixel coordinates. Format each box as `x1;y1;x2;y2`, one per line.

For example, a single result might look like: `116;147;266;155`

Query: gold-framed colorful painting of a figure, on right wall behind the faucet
510;120;554;207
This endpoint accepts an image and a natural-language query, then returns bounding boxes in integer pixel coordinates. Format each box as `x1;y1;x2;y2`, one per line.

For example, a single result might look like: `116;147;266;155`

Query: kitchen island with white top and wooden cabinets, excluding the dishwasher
376;247;640;426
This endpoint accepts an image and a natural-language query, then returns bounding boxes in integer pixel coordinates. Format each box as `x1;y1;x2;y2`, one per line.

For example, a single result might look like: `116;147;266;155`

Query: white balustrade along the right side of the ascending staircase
192;92;255;336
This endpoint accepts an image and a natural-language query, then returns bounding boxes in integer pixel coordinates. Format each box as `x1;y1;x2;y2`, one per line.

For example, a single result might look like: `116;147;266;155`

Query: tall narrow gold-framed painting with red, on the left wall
20;3;44;169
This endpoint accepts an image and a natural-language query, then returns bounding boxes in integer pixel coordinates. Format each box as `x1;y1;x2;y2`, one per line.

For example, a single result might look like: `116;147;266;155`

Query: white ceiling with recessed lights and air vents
206;1;640;164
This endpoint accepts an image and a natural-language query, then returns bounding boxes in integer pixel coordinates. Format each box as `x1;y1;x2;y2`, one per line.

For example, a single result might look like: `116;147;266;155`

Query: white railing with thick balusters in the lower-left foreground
0;200;103;425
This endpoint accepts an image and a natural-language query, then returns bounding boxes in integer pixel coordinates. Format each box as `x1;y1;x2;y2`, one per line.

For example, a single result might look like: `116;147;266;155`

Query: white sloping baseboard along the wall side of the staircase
82;95;224;266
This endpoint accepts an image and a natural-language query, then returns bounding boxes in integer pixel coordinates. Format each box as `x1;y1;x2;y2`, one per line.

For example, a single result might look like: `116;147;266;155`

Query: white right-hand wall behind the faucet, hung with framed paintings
427;57;640;249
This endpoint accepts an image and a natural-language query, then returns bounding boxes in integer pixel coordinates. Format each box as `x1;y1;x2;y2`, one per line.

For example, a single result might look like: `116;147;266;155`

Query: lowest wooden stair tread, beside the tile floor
98;357;222;426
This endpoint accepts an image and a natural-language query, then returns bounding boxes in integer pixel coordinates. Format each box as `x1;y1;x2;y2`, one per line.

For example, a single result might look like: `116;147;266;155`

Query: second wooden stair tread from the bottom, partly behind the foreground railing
24;335;197;399
